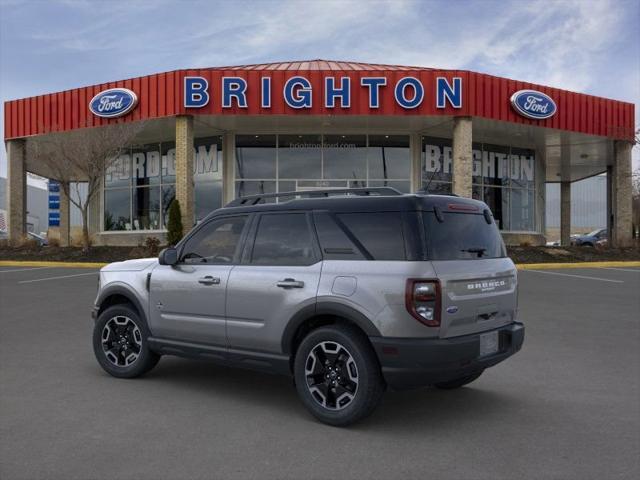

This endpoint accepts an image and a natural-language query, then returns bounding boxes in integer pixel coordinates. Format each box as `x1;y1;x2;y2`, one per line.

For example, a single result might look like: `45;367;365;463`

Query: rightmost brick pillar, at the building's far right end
611;141;632;247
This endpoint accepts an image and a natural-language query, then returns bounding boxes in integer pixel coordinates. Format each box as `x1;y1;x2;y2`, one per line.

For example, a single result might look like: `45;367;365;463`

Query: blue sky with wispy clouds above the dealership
0;0;640;182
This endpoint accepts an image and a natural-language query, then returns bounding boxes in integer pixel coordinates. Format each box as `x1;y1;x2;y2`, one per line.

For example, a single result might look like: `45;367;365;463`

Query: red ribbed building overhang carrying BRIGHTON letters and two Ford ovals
4;60;635;144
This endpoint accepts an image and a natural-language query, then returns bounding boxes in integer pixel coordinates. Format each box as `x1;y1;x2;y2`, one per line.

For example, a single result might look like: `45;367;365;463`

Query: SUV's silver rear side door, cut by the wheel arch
227;212;322;353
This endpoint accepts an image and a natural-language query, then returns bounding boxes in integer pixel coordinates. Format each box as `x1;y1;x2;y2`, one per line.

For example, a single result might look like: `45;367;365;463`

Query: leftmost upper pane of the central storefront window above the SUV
236;135;276;179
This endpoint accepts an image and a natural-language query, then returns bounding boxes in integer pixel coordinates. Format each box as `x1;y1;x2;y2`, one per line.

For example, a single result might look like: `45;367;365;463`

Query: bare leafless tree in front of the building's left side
27;122;143;250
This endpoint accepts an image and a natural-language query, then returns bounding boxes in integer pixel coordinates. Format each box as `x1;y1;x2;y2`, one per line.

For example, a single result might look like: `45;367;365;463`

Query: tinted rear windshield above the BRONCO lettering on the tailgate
423;212;506;260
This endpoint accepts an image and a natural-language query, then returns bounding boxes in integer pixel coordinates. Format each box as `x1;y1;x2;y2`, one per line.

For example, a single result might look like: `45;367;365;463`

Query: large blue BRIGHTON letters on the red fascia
183;76;462;110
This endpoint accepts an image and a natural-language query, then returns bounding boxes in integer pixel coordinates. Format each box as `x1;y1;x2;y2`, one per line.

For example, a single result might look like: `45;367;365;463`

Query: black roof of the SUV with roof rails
208;192;488;221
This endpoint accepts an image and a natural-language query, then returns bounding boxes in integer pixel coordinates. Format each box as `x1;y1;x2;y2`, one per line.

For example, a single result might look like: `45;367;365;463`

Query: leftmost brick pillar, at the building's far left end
7;140;27;244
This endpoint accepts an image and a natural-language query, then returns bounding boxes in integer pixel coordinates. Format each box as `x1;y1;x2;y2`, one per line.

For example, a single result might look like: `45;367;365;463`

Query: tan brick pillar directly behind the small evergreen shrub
176;115;195;234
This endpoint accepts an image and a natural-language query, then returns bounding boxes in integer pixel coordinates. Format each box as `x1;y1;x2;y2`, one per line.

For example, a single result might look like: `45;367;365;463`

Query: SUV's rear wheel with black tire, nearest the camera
294;325;384;427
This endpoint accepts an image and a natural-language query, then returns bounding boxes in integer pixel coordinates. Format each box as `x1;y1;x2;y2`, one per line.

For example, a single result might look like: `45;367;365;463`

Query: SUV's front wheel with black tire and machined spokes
93;304;160;378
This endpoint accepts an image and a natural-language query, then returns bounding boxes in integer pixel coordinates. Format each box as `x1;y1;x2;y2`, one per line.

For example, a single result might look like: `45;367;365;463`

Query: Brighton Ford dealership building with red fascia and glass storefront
4;60;634;245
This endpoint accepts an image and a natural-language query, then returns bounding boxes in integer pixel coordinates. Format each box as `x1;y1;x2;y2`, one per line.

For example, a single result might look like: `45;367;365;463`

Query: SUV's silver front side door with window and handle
149;215;249;347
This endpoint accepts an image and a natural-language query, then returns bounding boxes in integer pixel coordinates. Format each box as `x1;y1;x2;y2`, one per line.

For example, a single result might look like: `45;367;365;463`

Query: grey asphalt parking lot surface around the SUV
0;267;640;480
